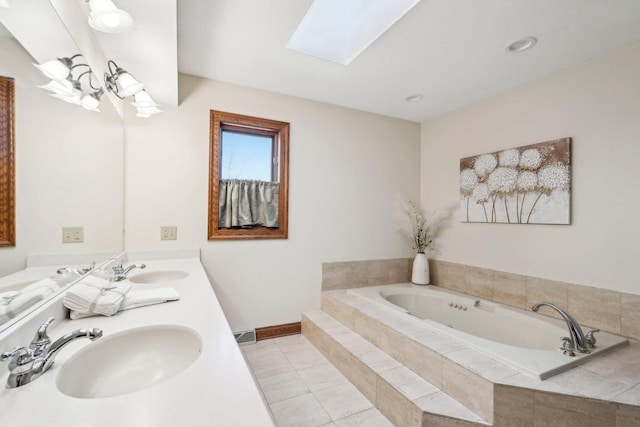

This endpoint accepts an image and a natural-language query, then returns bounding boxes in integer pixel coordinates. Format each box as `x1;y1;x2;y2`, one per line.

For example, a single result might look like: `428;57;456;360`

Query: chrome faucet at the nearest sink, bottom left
0;317;102;388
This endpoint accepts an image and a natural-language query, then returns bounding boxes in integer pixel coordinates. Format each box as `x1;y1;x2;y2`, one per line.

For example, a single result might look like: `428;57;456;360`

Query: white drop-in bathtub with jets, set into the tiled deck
348;283;628;379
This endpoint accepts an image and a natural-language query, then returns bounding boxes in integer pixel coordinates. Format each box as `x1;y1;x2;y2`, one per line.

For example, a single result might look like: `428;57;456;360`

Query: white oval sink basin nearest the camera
56;325;202;399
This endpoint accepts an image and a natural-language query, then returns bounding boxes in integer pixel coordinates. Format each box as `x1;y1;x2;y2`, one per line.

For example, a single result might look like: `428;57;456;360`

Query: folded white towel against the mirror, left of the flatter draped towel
62;276;131;316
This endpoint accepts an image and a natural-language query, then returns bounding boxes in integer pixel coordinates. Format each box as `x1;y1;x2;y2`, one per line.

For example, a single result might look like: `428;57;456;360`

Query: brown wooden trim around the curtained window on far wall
208;110;289;240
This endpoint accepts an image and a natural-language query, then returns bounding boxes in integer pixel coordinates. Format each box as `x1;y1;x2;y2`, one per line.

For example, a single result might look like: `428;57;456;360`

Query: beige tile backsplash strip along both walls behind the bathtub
322;258;640;339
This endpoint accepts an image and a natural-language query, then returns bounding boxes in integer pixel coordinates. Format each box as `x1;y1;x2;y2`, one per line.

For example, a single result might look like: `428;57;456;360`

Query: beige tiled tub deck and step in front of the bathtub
302;291;640;427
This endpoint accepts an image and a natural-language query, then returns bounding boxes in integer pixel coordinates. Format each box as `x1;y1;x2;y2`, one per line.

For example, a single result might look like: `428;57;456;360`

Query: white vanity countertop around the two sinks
0;259;273;427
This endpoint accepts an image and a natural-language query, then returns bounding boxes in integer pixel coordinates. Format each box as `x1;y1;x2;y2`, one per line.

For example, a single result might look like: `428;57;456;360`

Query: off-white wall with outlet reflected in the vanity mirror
0;37;123;276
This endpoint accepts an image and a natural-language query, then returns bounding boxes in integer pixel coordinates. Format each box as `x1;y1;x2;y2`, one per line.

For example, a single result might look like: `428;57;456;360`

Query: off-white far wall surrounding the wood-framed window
125;75;420;330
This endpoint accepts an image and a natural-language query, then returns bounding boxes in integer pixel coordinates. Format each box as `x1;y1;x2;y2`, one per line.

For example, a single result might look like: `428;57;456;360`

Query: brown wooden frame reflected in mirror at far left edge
0;76;16;246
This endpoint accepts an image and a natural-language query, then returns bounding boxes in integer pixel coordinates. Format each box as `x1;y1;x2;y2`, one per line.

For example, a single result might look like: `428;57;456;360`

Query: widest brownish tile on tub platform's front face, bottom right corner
533;392;616;427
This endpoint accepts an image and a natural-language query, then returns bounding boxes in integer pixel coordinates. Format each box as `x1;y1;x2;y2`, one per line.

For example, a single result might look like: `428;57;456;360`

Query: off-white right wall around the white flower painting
420;43;640;294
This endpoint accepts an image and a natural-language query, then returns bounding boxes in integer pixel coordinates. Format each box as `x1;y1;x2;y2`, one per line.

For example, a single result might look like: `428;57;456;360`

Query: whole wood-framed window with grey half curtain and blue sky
208;110;289;240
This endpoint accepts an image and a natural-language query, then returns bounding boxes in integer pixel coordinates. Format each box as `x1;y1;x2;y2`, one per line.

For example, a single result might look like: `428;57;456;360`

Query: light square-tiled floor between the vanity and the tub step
241;335;393;427
